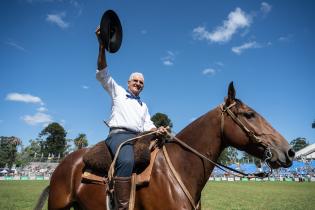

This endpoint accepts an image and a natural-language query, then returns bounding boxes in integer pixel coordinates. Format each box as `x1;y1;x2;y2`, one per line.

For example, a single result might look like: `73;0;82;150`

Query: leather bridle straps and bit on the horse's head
220;102;272;175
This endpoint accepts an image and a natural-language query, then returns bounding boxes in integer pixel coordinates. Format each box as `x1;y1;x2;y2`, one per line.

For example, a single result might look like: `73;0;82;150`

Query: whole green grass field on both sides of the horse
0;181;315;210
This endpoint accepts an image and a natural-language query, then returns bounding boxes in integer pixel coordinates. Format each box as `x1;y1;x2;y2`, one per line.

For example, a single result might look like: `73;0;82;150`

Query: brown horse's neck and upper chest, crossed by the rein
166;108;222;198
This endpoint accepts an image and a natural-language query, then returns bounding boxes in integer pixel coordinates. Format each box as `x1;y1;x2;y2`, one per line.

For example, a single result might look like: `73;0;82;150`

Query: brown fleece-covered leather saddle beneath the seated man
82;132;159;186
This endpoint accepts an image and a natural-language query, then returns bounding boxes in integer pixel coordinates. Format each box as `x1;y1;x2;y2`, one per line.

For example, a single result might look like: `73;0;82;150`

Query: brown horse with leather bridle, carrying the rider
36;83;295;210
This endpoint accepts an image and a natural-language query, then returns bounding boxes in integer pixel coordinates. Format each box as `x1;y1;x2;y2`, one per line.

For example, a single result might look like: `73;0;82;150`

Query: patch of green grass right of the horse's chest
202;182;315;210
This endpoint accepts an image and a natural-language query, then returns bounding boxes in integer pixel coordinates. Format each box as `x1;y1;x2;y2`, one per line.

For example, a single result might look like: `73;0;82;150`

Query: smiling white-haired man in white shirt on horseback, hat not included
95;27;167;209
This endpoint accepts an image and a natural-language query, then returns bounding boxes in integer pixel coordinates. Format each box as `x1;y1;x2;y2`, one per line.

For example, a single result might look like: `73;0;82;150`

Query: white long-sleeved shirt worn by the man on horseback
96;68;155;132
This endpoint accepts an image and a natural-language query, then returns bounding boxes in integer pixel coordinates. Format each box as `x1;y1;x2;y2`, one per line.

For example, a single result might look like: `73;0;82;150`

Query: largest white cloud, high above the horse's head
193;8;251;42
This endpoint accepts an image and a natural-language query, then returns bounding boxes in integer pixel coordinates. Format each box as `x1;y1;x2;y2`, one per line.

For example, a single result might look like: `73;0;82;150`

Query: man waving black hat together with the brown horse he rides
35;12;295;210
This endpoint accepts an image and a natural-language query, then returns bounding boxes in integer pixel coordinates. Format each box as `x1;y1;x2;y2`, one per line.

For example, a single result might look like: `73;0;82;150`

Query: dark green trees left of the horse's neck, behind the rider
0;113;173;168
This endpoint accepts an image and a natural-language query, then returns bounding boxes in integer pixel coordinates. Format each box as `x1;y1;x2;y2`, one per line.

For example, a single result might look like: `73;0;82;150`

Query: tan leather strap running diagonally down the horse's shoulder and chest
163;146;200;210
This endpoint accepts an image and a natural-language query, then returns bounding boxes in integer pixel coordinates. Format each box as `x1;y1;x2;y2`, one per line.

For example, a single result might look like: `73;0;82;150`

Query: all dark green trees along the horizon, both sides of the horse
0;113;314;168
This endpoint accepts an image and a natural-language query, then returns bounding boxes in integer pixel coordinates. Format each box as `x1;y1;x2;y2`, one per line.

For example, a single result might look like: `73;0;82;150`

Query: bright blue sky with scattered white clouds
0;0;315;148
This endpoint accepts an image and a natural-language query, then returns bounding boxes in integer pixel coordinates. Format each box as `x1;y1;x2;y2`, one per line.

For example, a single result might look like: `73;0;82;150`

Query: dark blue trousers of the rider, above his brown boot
105;131;137;177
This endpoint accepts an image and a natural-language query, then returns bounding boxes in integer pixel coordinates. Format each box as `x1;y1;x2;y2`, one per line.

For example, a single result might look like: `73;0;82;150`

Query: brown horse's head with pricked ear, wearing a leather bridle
220;82;295;168
